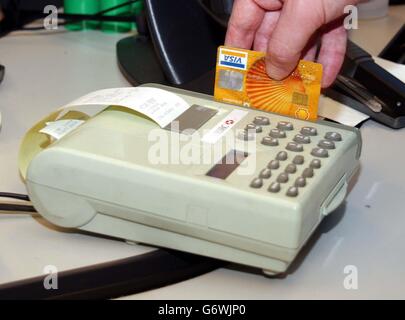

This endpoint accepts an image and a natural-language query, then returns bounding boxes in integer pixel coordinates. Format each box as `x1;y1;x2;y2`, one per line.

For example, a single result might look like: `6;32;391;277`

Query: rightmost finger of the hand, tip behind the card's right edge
318;21;347;88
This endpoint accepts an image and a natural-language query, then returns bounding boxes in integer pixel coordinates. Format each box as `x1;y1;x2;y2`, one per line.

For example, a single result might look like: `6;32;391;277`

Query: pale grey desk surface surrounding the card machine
0;6;405;299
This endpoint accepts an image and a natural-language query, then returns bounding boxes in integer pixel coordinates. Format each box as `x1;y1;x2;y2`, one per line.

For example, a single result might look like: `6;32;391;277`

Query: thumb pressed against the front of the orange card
266;0;354;80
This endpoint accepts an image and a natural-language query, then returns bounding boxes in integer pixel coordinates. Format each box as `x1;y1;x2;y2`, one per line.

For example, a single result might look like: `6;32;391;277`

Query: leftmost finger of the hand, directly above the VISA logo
225;0;265;49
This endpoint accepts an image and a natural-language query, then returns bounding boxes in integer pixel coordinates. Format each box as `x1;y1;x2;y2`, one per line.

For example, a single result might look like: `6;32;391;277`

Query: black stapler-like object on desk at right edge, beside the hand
324;41;405;129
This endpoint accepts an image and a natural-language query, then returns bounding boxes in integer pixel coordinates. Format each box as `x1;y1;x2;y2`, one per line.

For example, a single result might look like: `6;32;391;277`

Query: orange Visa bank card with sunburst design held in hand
214;46;322;120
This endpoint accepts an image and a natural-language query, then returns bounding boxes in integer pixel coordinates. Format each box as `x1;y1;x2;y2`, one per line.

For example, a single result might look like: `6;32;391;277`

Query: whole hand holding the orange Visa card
225;0;360;88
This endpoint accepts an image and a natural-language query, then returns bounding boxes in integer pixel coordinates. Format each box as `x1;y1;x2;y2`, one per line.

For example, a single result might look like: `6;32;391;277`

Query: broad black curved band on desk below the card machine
0;249;225;300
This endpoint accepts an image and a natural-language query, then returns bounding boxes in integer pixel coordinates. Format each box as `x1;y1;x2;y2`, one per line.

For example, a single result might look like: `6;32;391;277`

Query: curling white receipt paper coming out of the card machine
18;87;190;180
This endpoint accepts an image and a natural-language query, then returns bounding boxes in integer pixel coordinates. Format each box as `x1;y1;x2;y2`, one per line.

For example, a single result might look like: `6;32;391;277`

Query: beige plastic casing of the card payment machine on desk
26;85;361;274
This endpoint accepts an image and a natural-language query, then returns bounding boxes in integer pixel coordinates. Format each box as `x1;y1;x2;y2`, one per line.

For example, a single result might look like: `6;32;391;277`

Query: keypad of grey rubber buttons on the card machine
245;116;343;198
